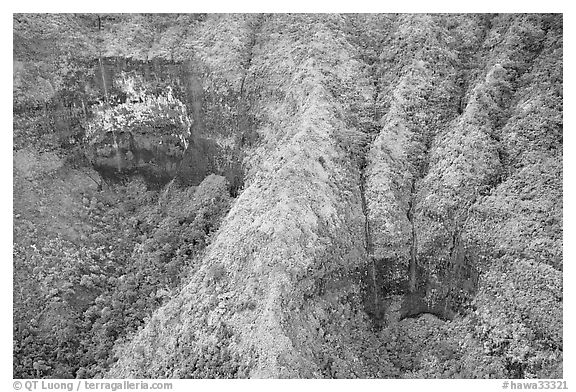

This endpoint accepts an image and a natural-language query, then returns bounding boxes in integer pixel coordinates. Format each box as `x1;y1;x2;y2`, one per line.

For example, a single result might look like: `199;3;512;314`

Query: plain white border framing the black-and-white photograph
0;4;576;392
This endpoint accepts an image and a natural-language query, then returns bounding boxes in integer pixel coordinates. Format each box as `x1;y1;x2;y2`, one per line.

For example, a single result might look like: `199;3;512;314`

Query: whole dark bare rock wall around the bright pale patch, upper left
83;58;249;188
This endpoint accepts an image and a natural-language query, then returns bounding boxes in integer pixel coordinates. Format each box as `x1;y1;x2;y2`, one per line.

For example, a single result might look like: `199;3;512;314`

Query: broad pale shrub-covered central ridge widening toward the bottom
111;16;394;377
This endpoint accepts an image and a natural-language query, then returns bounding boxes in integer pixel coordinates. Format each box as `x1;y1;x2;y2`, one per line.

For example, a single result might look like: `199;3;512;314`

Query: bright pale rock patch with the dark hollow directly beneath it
86;73;191;182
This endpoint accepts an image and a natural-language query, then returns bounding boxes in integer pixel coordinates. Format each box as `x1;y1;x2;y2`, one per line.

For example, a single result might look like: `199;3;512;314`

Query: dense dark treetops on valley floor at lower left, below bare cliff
14;170;230;378
